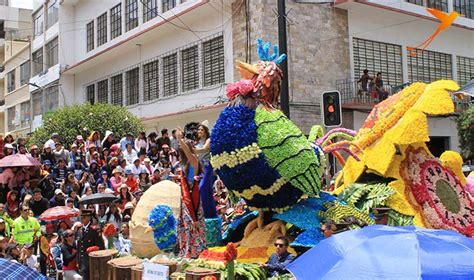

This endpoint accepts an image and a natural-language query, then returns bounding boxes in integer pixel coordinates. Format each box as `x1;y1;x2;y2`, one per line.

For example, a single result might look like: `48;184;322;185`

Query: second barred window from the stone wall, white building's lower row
181;46;199;91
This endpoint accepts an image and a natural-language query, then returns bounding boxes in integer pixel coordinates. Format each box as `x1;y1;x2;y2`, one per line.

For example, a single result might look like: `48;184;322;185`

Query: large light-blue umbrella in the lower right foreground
287;225;474;280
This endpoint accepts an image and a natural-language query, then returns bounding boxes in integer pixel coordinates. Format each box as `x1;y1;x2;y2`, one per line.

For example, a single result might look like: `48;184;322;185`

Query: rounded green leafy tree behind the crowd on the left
30;103;143;147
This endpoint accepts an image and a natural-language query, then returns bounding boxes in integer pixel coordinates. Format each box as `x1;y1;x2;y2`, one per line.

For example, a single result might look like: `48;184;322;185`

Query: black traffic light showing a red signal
321;90;342;127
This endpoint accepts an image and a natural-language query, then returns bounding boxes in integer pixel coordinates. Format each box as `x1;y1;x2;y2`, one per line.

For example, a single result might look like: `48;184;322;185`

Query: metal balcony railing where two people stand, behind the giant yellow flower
336;79;470;112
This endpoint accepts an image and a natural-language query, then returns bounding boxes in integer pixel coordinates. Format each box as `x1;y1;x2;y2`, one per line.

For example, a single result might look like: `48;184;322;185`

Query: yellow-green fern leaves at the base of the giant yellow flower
339;182;395;213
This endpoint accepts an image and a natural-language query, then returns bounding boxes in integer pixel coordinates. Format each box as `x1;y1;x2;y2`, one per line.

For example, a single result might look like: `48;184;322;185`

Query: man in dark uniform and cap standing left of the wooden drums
77;209;105;280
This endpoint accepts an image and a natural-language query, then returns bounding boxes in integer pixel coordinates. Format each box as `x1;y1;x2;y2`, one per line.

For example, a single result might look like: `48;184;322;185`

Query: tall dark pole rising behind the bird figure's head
278;0;290;118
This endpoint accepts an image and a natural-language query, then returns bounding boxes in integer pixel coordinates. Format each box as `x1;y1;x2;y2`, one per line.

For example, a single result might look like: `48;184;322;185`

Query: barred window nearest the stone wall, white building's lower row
202;36;225;86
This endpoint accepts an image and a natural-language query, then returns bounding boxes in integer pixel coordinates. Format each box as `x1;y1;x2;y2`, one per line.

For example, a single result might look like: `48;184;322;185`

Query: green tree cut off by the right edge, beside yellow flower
458;103;474;159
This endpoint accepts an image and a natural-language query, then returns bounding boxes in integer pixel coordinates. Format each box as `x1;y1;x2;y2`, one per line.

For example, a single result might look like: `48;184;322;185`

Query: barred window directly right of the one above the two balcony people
407;50;452;83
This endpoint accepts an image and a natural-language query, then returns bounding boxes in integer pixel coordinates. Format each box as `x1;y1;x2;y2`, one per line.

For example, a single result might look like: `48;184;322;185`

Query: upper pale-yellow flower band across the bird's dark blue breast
211;143;262;170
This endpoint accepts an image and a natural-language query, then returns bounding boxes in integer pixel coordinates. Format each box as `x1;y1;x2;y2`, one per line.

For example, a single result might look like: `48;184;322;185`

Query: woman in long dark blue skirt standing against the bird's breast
194;121;217;219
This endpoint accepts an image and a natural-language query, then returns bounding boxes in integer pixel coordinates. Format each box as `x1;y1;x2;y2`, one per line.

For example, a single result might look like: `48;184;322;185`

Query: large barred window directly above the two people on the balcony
353;38;403;86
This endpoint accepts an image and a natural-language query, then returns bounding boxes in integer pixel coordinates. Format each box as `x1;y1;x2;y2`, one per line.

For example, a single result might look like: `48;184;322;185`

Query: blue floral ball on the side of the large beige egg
148;205;177;252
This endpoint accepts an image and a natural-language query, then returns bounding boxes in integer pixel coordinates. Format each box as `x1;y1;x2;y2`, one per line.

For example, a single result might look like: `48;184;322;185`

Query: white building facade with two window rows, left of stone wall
59;0;233;131
